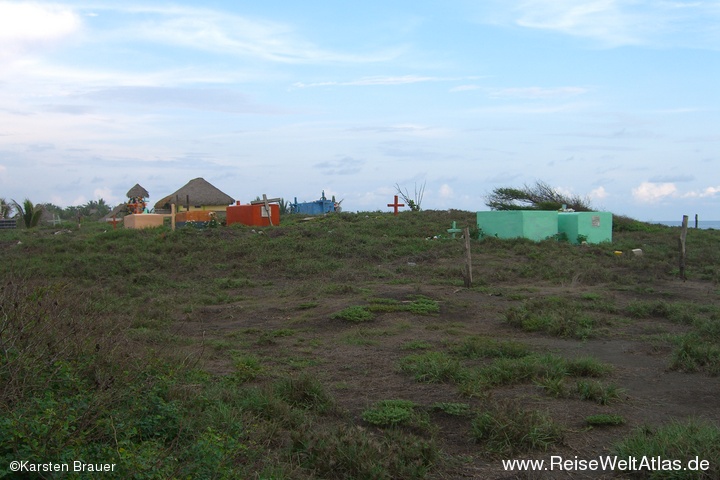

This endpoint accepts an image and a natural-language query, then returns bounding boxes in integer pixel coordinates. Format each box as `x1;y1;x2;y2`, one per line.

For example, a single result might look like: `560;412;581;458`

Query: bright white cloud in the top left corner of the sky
0;1;82;59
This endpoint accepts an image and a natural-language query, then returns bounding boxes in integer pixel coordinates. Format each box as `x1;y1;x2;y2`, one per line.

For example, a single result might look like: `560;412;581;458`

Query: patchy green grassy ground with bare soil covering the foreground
0;211;720;479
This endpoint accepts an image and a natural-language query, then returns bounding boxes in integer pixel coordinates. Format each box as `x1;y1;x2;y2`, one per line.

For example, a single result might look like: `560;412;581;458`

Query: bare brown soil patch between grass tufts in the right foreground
182;274;720;478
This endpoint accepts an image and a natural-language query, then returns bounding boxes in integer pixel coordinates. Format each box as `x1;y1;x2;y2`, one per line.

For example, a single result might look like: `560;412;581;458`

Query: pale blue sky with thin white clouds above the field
0;0;720;221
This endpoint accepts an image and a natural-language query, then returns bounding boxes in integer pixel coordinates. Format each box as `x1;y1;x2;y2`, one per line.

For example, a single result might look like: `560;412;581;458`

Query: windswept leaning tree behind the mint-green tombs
485;181;592;212
